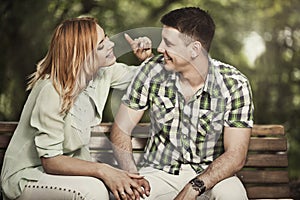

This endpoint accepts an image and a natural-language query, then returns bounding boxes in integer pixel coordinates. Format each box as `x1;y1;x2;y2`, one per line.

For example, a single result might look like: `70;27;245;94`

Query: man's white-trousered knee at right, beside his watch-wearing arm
210;176;248;200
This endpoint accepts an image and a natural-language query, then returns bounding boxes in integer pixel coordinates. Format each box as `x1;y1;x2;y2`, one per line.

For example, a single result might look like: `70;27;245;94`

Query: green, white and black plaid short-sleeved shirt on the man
123;55;253;174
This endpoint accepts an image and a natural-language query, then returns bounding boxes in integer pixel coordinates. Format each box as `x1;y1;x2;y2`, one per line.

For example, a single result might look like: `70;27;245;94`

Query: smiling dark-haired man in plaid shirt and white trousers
111;7;253;200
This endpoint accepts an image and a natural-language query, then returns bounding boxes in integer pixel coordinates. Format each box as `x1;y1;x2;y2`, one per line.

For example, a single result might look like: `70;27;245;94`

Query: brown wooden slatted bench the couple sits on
0;122;291;199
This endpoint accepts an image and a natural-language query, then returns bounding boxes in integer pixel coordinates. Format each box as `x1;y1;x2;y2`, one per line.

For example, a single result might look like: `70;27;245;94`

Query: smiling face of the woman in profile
96;25;116;67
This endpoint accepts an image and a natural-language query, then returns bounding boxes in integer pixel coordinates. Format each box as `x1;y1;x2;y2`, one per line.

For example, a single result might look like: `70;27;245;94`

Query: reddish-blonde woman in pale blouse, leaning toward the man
1;17;151;200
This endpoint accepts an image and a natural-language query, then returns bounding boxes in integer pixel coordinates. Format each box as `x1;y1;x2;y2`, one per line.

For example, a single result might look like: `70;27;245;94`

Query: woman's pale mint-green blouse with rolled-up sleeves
1;63;137;199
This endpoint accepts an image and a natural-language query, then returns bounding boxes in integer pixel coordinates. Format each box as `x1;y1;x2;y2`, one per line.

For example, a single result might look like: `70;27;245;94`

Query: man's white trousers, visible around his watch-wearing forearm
140;165;248;200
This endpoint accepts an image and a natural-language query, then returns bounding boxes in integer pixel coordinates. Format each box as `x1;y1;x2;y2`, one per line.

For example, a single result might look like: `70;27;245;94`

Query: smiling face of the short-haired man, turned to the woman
157;26;191;72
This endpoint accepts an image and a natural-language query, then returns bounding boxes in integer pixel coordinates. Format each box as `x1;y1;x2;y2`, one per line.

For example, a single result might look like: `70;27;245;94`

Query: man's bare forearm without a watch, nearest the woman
110;124;138;173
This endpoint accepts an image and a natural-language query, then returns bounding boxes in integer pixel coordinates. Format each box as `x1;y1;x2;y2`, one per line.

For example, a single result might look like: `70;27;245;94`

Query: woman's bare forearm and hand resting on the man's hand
41;155;144;199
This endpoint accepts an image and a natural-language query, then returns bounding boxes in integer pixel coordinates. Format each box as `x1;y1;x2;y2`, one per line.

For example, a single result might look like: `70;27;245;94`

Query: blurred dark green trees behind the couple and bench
0;0;300;194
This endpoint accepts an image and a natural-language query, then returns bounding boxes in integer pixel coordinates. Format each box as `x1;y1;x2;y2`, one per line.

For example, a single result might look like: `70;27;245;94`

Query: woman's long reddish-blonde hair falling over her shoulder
27;17;98;113
